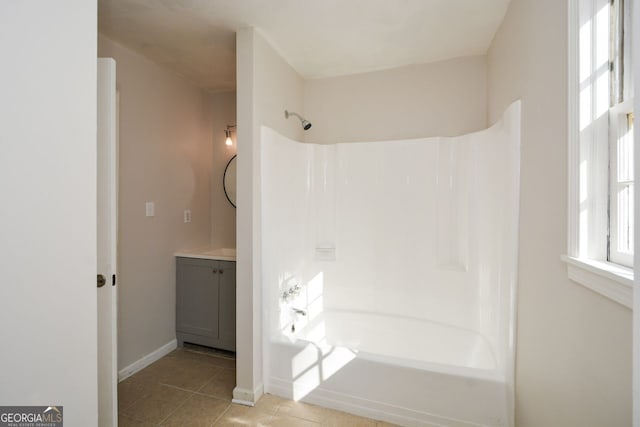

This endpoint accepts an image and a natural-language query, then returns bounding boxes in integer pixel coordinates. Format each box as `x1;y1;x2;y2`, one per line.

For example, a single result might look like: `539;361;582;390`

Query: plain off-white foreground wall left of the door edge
0;0;98;426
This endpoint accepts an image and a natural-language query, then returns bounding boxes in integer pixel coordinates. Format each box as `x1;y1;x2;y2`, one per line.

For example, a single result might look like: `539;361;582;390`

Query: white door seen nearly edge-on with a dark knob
97;58;118;427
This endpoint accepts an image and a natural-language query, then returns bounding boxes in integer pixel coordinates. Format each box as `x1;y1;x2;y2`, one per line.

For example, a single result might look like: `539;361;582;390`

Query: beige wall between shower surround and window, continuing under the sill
488;0;632;427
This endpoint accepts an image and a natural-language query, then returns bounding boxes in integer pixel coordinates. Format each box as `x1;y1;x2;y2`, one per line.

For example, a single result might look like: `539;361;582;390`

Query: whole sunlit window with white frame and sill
564;0;634;307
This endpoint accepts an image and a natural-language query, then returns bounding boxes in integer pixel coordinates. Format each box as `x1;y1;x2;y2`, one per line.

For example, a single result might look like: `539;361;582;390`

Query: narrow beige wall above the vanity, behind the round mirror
209;92;237;248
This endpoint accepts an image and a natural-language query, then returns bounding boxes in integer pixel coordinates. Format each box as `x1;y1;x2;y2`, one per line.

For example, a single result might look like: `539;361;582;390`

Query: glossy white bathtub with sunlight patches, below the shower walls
265;311;508;426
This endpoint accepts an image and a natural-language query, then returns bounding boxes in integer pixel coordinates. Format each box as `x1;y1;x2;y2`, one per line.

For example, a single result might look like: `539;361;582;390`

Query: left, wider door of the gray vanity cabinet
176;258;220;338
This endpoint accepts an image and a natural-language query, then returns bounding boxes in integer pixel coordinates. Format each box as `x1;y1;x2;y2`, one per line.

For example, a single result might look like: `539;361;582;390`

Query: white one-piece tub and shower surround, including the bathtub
261;101;520;426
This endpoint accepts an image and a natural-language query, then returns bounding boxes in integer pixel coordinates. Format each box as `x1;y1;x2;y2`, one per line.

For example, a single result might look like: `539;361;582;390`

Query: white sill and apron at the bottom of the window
562;255;633;309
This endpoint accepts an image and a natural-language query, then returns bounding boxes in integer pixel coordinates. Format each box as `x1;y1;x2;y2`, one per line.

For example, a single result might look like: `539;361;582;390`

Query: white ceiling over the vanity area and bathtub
98;0;510;92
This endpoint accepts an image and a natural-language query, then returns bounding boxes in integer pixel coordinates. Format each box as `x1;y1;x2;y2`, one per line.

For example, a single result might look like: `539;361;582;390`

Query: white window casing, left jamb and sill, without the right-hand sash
562;0;633;308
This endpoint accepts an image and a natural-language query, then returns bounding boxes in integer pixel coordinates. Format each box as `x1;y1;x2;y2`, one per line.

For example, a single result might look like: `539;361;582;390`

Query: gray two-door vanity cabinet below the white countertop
176;257;236;351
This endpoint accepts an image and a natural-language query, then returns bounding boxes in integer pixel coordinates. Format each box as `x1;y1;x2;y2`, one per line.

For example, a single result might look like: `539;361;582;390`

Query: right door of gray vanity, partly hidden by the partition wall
219;261;236;351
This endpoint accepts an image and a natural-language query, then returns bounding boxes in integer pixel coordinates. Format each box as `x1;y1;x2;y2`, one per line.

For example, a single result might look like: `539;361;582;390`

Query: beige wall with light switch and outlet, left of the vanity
98;36;213;369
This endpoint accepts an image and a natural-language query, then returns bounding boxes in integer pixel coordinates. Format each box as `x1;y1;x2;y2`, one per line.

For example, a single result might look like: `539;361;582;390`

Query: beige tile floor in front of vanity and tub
118;349;392;427
